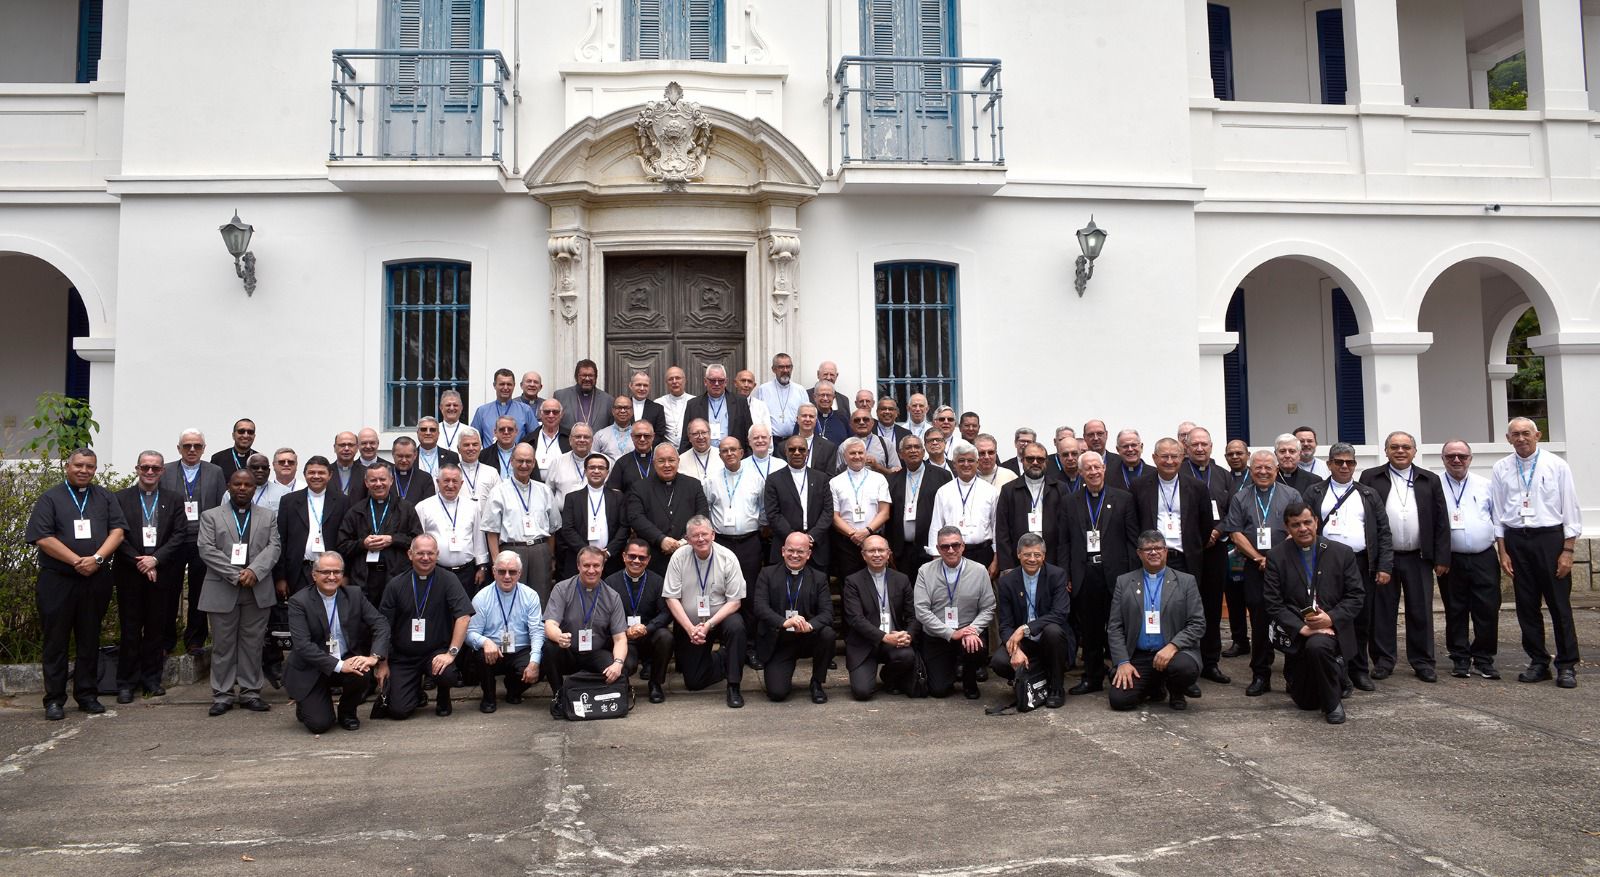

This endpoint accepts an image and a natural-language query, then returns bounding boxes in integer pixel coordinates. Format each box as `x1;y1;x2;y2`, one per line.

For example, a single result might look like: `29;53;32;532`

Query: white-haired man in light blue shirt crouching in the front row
467;551;544;712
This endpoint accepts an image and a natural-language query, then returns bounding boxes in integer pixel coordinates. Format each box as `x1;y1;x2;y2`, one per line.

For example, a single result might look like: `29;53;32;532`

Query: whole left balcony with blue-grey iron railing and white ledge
328;50;515;192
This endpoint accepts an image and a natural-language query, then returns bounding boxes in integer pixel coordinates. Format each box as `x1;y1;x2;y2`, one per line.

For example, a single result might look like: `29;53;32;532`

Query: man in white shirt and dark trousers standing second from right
1438;439;1497;679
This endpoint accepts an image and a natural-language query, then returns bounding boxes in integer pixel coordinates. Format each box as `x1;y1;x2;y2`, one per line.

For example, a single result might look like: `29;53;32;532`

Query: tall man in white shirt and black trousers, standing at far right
1490;418;1584;688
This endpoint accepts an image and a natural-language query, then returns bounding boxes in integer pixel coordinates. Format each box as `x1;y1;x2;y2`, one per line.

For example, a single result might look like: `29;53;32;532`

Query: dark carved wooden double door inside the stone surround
603;253;746;397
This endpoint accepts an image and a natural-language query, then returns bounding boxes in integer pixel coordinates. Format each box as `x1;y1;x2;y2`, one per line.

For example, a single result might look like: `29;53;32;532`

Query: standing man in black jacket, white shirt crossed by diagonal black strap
1306;442;1395;691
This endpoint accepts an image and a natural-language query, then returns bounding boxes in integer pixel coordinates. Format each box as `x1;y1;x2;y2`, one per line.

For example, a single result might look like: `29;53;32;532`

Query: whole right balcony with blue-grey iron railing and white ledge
834;54;1005;194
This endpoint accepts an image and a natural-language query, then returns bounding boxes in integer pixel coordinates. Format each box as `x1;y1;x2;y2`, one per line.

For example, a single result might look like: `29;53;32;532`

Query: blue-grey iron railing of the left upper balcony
328;50;510;162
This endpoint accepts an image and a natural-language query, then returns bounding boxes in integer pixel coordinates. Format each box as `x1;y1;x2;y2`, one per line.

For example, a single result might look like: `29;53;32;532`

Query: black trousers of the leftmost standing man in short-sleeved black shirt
37;568;112;706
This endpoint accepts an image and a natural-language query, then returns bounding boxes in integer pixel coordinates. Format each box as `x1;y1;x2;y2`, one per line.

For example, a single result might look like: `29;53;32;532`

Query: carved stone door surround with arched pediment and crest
523;83;822;386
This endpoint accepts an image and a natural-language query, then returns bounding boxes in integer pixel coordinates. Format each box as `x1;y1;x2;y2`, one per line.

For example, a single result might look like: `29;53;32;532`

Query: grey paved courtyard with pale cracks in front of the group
0;605;1600;877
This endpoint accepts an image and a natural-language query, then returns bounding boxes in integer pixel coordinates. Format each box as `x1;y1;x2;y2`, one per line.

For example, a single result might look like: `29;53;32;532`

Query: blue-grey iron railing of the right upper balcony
834;54;1005;165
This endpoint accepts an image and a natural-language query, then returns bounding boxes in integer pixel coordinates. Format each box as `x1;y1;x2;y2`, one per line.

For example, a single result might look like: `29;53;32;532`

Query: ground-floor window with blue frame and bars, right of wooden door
872;262;960;411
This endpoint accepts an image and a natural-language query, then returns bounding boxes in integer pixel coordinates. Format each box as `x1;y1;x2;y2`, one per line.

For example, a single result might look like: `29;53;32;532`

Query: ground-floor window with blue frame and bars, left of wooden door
384;262;472;429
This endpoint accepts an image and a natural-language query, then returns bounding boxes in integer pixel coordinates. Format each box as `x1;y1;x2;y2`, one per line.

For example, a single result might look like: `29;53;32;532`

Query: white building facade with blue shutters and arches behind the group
0;0;1600;527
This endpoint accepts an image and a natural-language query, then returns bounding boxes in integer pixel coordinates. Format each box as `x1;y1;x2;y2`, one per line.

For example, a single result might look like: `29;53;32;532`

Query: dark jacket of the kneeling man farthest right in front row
1262;538;1366;661
